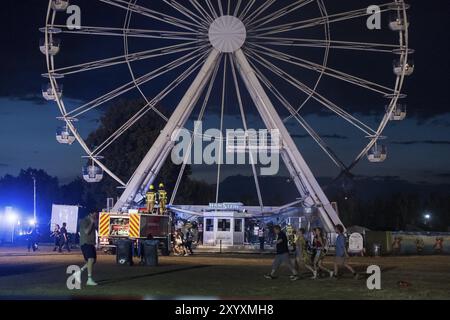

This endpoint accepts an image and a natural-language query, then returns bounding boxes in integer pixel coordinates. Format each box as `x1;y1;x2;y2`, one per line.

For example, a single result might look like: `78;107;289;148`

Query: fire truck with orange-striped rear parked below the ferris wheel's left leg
98;211;172;255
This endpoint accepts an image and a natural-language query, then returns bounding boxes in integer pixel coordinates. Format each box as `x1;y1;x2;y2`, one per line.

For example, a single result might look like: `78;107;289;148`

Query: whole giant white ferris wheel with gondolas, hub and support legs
40;0;414;229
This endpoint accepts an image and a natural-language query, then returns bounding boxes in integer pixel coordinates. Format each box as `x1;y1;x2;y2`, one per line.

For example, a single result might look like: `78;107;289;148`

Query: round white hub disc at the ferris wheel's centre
209;16;247;53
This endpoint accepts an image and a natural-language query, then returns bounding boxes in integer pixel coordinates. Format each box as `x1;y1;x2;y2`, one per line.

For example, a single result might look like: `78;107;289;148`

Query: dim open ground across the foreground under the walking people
0;249;450;300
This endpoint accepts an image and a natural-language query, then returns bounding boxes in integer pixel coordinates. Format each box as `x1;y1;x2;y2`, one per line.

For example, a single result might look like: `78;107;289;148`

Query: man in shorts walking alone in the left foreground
79;212;98;286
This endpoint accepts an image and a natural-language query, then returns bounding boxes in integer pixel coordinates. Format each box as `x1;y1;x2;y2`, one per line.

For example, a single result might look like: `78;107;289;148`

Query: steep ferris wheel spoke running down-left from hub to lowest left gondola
94;48;212;156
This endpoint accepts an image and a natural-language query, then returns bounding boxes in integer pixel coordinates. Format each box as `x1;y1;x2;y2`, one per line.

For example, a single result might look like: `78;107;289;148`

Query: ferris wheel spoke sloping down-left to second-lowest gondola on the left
66;47;204;118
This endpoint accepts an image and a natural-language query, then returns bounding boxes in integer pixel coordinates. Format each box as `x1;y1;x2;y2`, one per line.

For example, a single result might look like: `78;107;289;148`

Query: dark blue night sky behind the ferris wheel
0;0;450;190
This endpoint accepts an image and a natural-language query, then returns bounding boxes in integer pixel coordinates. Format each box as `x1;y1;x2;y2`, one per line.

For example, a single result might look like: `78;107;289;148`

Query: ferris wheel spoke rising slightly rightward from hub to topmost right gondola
252;2;398;36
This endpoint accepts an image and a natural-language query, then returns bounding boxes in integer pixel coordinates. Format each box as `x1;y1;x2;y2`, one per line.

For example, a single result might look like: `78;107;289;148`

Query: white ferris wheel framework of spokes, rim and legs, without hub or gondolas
44;0;412;230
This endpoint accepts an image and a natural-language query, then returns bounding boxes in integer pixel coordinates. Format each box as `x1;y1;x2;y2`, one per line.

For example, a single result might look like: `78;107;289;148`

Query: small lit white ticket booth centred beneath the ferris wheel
203;211;245;246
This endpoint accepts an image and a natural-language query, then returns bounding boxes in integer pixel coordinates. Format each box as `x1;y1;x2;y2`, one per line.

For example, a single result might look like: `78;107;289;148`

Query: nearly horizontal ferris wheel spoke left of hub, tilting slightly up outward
54;25;203;41
